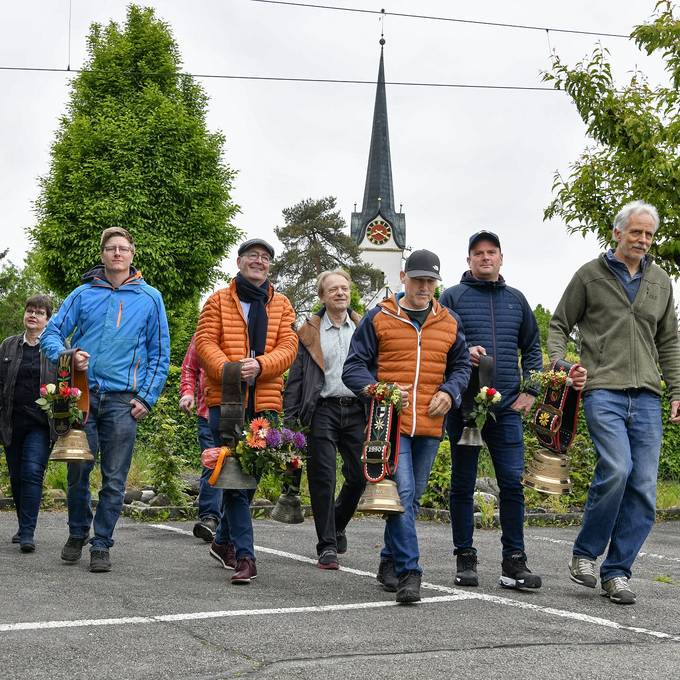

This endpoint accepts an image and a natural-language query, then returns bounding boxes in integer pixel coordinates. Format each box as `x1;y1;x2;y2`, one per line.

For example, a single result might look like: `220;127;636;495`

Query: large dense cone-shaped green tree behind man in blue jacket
30;5;239;322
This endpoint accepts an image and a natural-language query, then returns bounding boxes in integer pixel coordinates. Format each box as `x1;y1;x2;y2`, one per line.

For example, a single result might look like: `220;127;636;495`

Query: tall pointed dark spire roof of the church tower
351;38;406;250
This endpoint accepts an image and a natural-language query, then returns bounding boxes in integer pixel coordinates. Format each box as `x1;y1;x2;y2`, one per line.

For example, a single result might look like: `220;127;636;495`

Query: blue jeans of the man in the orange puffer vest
380;434;439;575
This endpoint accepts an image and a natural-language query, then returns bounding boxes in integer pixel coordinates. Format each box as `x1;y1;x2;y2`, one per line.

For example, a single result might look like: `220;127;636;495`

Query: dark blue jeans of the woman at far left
5;425;50;541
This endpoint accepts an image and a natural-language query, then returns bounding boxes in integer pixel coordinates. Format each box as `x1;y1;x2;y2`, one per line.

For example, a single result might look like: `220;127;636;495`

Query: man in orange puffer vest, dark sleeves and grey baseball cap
342;250;470;603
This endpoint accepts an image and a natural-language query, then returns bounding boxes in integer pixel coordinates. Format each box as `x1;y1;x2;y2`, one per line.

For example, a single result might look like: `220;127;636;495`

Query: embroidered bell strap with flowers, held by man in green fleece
534;359;581;453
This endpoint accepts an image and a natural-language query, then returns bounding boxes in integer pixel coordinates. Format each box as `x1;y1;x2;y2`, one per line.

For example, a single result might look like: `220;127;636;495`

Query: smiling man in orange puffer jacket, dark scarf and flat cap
196;238;298;583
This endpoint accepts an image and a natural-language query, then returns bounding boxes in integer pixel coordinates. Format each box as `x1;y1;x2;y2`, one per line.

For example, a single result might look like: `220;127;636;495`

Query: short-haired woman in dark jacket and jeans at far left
0;295;56;553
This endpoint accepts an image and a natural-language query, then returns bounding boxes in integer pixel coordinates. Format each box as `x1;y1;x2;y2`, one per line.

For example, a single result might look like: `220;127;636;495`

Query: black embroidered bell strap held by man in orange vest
361;399;401;483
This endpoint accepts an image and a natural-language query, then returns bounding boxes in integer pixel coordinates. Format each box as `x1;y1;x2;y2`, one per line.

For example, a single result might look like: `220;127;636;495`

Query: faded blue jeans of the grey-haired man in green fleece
574;389;661;581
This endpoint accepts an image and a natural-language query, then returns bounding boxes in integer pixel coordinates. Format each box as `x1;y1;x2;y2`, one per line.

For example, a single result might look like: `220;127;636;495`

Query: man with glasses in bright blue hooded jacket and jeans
40;227;170;572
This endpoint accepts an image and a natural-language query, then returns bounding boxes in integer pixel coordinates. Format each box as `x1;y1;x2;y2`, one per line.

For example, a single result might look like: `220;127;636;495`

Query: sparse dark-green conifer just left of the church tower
271;196;383;316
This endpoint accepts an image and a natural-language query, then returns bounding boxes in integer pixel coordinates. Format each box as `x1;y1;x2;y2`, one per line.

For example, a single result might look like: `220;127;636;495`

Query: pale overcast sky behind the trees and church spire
0;0;665;309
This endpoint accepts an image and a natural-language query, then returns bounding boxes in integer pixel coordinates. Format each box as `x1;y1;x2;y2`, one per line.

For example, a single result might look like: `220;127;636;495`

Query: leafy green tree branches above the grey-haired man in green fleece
544;2;680;276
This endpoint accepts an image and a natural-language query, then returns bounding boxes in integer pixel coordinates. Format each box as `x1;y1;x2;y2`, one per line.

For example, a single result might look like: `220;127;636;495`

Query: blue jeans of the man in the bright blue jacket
68;392;137;550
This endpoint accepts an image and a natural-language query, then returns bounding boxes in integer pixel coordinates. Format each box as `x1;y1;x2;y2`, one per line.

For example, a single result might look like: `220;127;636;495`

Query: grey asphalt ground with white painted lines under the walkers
0;512;680;680
